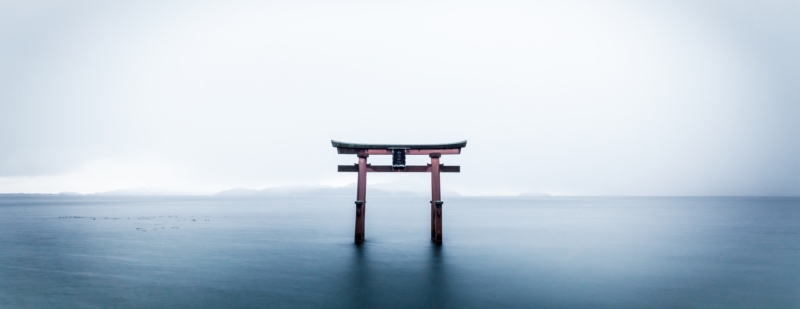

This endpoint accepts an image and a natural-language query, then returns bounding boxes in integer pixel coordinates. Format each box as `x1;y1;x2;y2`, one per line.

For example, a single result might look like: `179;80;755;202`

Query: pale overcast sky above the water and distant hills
0;1;800;195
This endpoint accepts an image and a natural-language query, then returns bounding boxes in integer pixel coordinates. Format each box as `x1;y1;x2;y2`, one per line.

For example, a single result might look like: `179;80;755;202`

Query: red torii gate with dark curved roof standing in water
331;140;467;244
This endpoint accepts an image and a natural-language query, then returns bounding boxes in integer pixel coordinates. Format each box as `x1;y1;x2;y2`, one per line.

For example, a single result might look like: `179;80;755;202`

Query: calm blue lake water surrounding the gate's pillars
0;196;800;308
